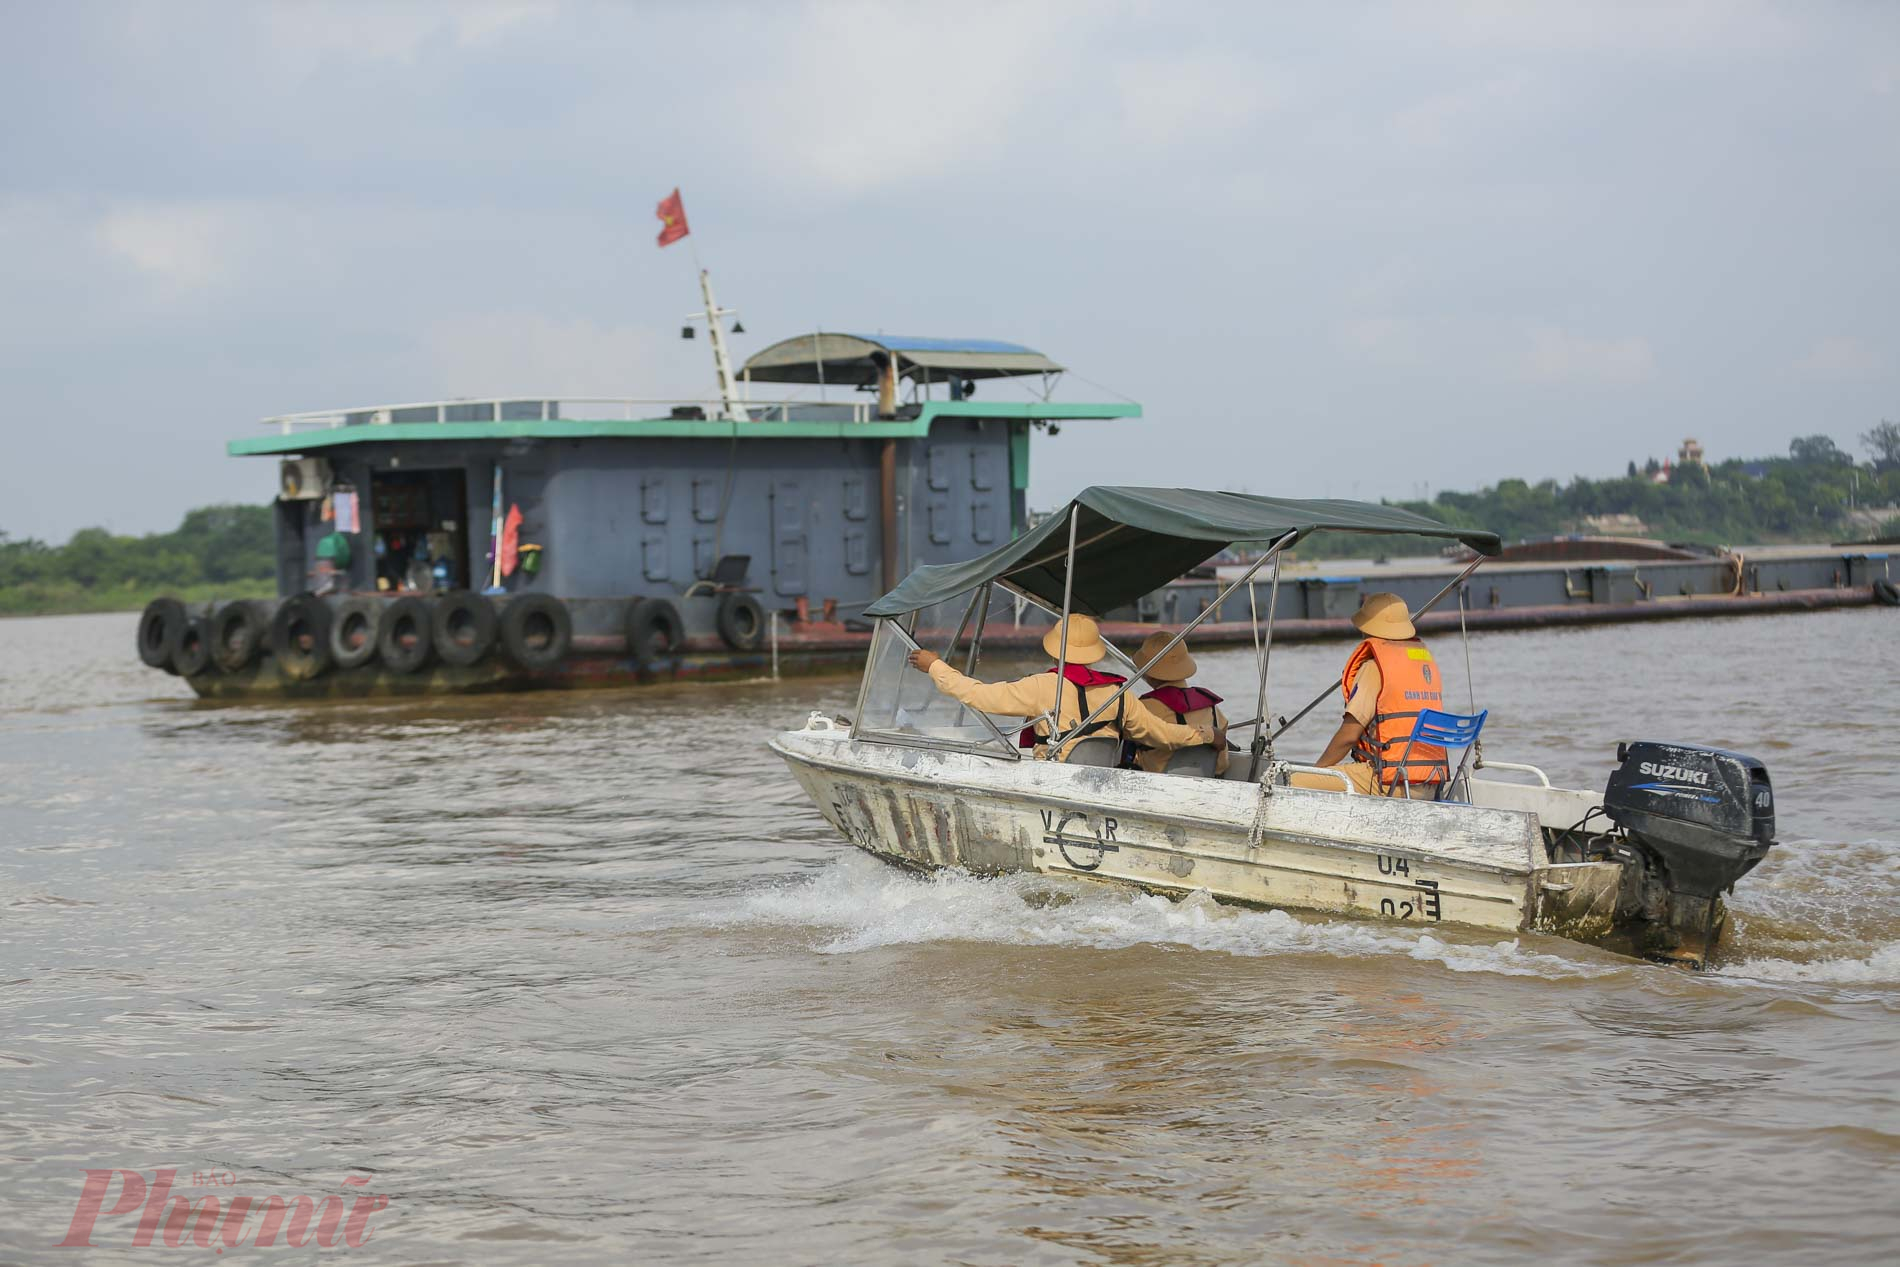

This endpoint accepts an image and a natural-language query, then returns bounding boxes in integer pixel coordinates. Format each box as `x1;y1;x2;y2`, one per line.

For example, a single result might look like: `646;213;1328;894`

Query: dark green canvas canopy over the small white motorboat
865;486;1501;617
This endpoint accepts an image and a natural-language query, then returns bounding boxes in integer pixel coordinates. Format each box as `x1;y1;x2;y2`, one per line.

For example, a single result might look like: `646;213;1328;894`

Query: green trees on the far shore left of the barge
0;505;276;615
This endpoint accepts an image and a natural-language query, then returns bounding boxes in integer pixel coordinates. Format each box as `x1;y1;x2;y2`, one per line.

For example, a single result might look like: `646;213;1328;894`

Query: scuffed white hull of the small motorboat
771;728;1623;942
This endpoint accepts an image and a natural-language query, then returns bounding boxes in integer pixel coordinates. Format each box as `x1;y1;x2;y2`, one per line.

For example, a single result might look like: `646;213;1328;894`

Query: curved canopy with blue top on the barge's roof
739;334;1062;388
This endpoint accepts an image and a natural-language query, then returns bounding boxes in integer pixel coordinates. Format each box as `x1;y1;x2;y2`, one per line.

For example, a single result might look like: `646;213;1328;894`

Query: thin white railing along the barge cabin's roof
264;395;874;435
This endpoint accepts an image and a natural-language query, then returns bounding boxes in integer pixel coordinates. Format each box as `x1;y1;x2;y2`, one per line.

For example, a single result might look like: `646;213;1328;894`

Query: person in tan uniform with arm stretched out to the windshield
910;615;1214;760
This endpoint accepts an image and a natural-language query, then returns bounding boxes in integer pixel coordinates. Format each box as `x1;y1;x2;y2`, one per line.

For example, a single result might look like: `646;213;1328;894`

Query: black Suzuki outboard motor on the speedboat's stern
1604;741;1775;965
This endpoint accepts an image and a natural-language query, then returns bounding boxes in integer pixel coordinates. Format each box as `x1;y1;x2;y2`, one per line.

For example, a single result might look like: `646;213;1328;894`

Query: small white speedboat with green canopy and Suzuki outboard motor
771;486;1775;967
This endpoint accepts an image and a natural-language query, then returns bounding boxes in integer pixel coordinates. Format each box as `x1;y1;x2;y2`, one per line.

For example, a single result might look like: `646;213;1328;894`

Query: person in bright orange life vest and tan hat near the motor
1290;595;1452;800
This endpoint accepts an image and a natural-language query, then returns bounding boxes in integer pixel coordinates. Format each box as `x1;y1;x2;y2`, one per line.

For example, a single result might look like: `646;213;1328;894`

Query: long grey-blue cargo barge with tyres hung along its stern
139;311;1892;699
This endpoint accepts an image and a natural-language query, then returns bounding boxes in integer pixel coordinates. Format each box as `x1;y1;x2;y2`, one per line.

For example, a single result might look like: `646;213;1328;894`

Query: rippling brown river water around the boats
0;610;1900;1265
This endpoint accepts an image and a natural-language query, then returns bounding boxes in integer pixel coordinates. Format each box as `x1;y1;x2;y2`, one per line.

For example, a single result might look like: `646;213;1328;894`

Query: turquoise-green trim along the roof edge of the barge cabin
224;401;1142;458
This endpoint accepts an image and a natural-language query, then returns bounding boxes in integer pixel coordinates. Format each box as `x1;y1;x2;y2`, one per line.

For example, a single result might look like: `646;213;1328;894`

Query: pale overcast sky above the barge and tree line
0;0;1900;539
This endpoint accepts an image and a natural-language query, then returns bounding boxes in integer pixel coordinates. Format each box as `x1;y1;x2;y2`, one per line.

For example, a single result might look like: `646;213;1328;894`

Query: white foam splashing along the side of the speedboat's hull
720;853;1621;978
